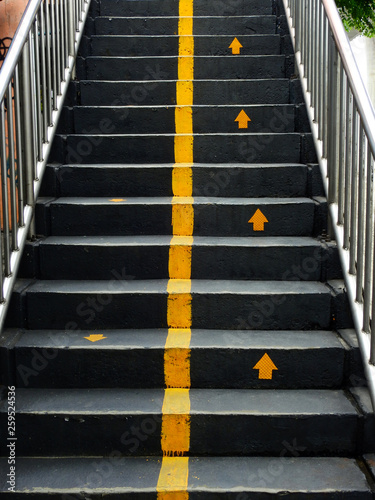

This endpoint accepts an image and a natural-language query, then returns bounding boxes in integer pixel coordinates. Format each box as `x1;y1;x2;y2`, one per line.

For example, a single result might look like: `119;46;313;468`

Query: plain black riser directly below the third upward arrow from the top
39;241;327;281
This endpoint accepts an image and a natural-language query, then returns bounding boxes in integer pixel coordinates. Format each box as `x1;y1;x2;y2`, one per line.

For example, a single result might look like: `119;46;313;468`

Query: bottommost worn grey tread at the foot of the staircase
0;458;372;500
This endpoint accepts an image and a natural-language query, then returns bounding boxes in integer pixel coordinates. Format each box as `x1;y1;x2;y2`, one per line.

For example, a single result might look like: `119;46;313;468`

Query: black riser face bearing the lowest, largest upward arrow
15;346;344;389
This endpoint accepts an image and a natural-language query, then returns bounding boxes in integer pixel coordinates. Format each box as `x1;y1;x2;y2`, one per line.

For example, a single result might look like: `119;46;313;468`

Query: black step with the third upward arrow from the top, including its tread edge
37;193;315;237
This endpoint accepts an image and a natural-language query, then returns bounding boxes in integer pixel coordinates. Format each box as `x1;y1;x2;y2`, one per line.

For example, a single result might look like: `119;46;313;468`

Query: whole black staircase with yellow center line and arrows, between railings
0;0;375;500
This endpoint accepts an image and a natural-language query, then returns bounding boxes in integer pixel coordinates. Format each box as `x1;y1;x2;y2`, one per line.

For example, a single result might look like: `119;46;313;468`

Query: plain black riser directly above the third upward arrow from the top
44;165;308;199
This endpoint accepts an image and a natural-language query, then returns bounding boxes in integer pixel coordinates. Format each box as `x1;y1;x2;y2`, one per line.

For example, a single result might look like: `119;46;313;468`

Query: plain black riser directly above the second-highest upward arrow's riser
79;79;290;106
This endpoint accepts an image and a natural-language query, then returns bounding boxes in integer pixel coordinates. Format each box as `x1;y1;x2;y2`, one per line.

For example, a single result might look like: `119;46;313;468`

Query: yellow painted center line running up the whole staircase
157;0;194;494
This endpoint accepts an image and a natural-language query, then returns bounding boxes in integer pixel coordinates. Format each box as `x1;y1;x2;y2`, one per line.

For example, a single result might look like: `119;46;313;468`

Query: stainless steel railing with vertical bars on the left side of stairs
0;0;90;330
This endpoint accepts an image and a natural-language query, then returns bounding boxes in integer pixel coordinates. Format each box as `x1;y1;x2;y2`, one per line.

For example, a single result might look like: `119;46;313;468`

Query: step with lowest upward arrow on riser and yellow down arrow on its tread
2;330;349;390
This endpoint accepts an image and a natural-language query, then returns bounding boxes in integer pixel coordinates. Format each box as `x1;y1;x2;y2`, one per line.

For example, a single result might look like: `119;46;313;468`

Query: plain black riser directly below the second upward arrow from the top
50;132;306;165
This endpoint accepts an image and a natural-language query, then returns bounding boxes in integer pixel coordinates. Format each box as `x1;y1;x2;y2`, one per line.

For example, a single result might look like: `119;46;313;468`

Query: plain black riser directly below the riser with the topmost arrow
86;56;285;81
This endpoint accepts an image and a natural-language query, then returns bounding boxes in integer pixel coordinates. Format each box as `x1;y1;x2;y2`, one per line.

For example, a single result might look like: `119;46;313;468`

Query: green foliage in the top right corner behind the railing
336;0;375;37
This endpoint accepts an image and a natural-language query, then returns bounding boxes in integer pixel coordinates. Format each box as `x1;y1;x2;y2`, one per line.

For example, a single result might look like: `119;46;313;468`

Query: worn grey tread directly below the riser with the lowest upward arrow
0;389;358;419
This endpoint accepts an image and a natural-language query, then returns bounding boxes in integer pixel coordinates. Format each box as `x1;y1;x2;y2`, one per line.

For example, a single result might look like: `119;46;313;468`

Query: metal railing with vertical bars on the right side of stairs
283;0;375;410
